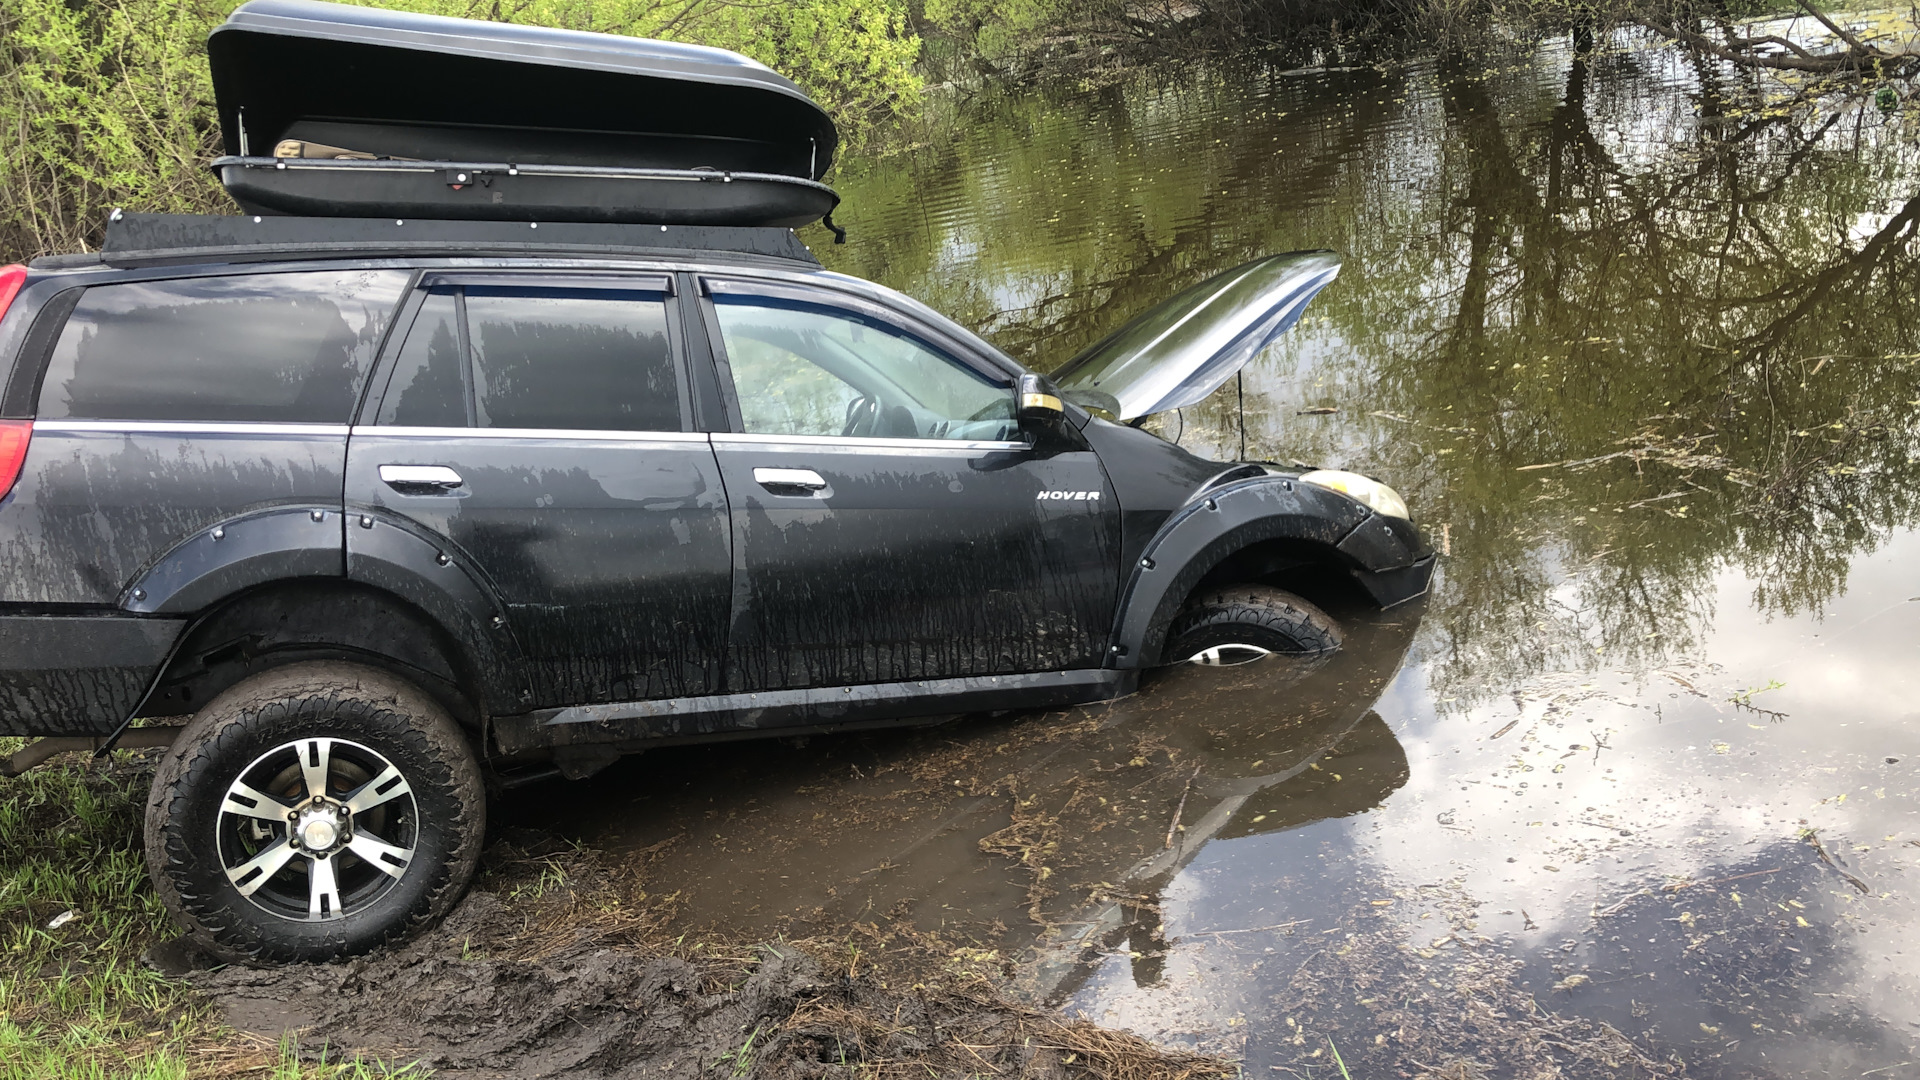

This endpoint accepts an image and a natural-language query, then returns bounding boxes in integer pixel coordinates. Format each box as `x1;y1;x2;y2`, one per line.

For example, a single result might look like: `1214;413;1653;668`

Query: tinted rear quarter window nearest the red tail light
38;269;411;423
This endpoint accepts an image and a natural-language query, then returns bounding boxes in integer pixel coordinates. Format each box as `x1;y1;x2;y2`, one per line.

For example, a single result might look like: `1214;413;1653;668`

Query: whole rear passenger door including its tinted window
348;275;732;707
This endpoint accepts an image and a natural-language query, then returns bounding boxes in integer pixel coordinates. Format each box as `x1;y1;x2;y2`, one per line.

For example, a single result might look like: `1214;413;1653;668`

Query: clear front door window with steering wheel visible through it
714;294;1018;440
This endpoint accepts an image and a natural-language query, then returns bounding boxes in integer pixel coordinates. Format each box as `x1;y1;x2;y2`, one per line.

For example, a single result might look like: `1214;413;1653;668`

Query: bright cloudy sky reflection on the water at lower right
1071;532;1920;1074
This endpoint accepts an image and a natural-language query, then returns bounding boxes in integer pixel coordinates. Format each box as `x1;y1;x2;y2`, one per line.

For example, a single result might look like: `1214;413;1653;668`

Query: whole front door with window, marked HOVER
701;277;1117;690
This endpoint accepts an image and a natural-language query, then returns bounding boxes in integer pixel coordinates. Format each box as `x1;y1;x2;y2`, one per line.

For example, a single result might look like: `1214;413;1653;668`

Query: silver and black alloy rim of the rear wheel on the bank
215;736;420;922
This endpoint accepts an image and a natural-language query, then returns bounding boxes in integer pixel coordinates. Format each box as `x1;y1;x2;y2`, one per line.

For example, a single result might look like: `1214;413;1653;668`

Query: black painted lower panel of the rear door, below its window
346;427;733;709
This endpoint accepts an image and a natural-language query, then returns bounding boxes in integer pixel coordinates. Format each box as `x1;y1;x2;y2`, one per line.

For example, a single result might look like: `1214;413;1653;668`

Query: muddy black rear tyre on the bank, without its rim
146;661;486;965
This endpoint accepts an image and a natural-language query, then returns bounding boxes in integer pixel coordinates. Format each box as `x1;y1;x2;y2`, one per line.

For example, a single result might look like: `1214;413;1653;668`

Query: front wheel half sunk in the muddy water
1162;584;1342;665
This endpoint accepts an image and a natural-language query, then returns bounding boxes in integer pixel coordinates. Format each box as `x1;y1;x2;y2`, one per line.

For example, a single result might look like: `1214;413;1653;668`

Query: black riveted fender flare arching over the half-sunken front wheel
1106;477;1373;667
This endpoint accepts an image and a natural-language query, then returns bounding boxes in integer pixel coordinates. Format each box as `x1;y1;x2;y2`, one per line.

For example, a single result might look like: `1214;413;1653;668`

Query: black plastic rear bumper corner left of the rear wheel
0;615;186;736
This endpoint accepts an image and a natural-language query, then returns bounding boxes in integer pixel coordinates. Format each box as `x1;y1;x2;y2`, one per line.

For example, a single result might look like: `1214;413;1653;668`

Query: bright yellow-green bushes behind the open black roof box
0;0;922;259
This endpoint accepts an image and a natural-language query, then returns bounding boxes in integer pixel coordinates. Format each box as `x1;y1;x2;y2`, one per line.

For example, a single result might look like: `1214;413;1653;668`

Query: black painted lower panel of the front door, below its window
714;434;1119;690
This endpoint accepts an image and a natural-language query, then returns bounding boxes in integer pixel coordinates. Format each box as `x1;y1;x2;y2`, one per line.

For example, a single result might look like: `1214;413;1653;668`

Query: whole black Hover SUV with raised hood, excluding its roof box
0;2;1432;961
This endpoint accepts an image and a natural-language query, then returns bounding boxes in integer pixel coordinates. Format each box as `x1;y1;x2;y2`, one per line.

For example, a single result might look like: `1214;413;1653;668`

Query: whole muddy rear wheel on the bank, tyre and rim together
146;663;486;963
